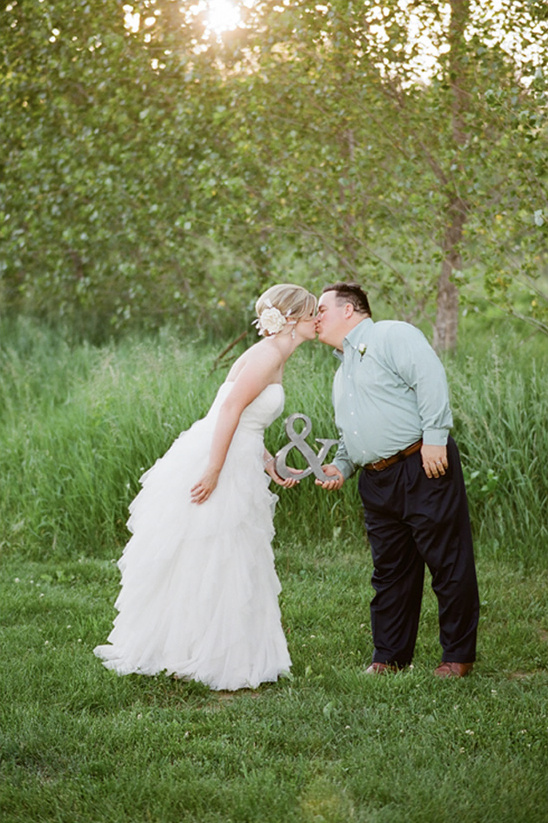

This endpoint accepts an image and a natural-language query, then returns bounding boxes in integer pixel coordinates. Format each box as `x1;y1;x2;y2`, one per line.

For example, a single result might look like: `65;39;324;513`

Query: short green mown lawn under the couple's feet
0;541;548;823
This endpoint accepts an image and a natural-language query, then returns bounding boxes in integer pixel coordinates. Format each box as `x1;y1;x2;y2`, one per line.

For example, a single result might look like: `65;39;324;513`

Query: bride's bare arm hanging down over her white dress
190;351;280;503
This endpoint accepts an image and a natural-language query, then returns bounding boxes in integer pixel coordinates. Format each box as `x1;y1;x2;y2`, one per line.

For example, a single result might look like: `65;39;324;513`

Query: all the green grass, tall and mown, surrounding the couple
0;322;548;823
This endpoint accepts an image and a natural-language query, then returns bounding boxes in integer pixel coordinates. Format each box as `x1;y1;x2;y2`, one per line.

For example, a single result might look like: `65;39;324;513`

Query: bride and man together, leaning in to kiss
94;283;479;691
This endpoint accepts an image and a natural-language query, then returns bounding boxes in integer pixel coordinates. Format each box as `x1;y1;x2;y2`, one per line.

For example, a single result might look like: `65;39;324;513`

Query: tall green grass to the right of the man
449;335;548;561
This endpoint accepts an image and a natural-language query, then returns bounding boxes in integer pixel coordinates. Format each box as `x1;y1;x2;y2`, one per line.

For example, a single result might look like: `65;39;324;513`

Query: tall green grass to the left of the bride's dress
0;328;214;556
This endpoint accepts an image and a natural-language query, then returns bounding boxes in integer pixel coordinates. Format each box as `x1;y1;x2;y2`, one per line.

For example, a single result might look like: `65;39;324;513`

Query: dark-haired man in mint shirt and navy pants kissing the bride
316;283;479;677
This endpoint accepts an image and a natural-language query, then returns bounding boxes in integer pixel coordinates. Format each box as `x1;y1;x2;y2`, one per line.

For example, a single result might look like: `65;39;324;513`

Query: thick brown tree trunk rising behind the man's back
434;0;470;352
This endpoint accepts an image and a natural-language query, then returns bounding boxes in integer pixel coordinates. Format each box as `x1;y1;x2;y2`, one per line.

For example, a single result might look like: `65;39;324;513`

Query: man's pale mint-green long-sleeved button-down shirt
333;318;453;479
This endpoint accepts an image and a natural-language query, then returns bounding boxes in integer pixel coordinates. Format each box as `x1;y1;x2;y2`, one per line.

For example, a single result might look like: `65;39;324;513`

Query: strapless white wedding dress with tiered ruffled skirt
94;382;291;691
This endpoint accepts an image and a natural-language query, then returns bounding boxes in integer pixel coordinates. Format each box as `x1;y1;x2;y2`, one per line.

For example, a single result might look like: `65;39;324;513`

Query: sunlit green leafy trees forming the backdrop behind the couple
0;0;548;349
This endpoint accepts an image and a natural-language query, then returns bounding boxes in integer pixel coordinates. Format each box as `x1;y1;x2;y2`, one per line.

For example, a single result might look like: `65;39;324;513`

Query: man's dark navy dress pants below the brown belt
359;438;479;666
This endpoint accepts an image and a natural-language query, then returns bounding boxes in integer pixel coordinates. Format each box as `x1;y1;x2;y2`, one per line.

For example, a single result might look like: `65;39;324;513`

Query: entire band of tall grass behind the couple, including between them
0;322;548;563
